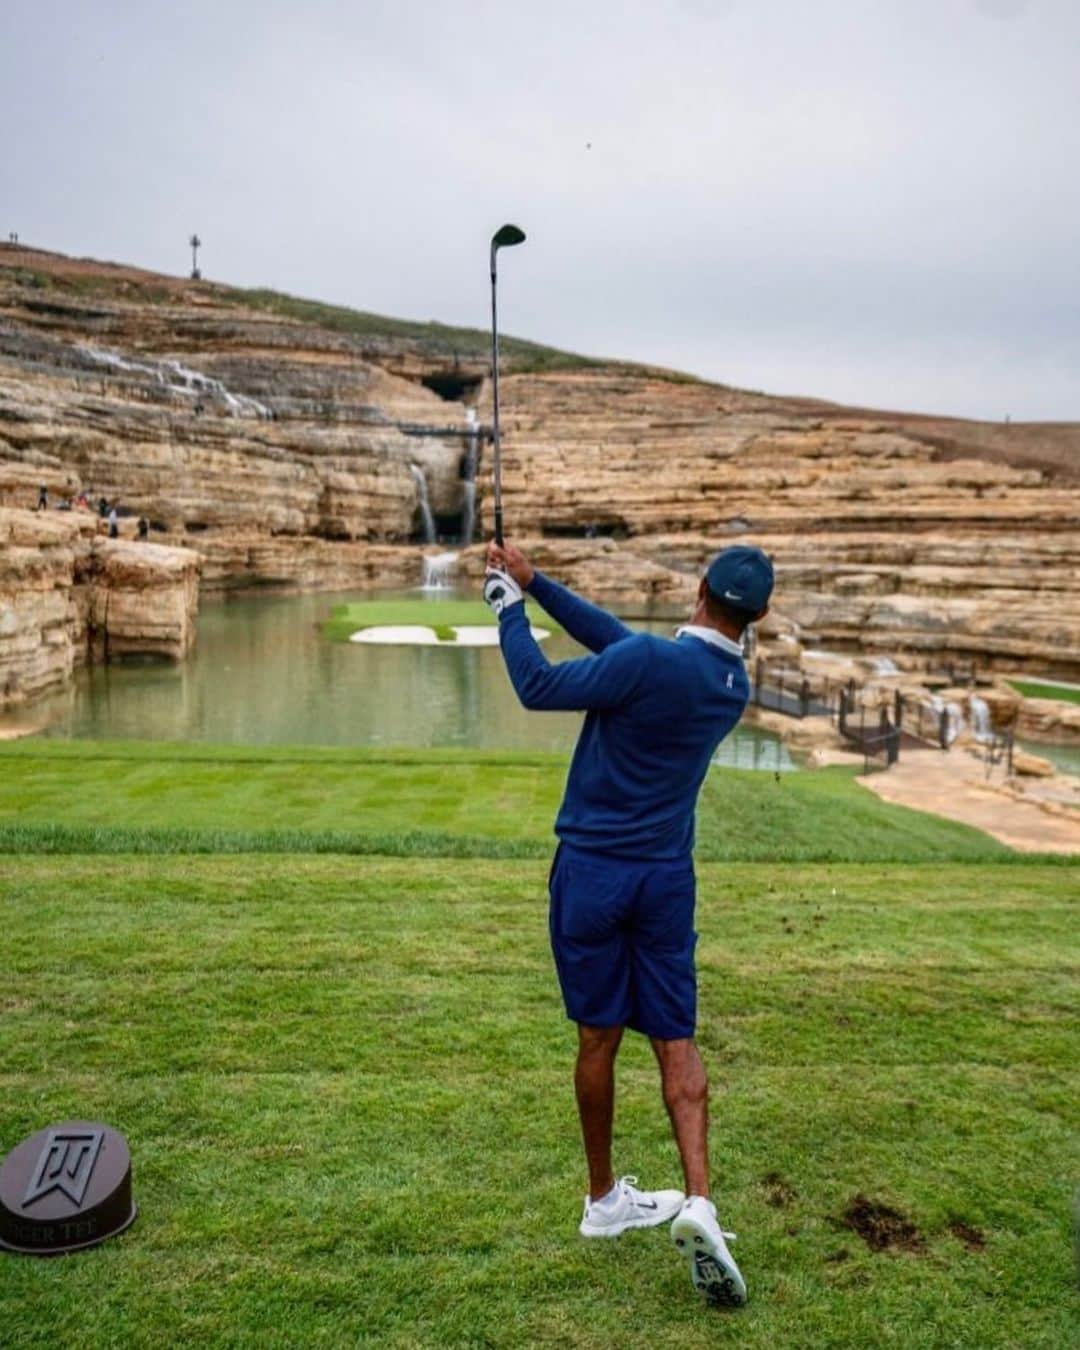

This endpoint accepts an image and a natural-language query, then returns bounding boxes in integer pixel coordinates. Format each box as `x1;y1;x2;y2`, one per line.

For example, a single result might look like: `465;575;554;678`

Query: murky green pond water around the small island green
8;593;795;771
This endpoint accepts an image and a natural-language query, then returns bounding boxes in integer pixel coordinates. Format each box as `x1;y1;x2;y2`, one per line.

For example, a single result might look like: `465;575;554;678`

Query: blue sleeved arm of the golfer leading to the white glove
498;603;648;711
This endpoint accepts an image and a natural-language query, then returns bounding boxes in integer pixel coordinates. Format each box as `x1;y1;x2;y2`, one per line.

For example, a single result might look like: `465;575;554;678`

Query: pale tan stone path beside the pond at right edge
859;751;1080;853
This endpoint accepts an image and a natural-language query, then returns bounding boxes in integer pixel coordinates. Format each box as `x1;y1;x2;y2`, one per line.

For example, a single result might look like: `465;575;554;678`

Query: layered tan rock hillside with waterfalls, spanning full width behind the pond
0;246;1080;707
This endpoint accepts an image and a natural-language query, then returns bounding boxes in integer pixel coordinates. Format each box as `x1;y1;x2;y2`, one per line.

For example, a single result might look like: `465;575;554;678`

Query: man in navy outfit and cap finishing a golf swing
483;544;772;1305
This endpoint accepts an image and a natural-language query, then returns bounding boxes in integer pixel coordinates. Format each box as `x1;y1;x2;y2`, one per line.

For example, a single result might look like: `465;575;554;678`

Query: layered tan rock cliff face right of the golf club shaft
505;371;1080;674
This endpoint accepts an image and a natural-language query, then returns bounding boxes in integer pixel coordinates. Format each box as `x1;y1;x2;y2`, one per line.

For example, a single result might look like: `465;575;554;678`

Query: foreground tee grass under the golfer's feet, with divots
0;856;1080;1350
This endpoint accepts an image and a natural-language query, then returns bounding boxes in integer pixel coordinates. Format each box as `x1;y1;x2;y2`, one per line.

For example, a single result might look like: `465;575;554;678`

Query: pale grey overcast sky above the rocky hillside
0;0;1080;419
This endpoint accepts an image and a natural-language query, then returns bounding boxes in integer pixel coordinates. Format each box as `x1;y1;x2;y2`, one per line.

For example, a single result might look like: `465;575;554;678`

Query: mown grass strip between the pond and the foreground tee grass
0;740;1047;861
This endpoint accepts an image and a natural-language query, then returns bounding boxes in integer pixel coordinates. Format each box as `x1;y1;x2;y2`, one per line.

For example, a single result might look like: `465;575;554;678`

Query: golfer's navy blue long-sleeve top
500;572;749;860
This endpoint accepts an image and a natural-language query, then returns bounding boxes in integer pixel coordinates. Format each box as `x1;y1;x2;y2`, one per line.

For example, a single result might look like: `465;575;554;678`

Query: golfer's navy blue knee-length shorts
548;844;698;1041
